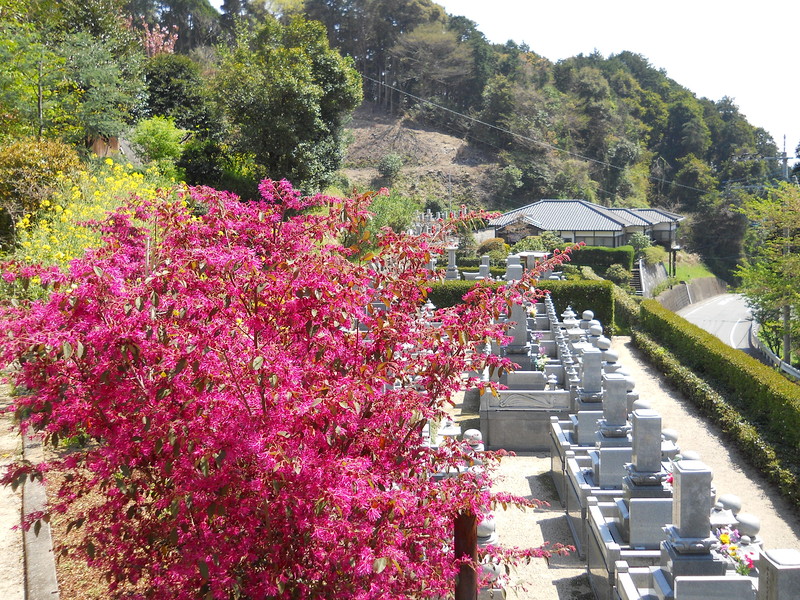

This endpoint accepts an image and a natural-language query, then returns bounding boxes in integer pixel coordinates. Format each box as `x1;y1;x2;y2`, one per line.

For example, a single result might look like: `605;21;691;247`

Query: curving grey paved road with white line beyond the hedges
677;294;753;351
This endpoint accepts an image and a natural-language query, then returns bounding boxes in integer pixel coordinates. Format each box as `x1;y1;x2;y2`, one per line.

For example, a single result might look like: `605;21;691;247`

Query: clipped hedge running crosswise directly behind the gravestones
428;280;614;329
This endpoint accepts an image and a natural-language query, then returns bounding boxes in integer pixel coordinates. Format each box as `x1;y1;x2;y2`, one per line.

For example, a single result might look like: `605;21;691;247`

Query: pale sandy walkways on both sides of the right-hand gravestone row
455;336;800;600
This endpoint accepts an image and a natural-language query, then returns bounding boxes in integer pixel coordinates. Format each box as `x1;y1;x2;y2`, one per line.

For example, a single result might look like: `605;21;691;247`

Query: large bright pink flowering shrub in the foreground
0;181;576;600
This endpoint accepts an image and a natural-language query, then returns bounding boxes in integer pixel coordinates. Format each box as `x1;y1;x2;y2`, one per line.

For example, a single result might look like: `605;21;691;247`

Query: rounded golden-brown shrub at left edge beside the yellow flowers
0;138;81;245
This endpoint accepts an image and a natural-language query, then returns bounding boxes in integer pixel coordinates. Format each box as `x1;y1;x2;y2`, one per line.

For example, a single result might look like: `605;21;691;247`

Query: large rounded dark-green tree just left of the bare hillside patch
215;17;362;190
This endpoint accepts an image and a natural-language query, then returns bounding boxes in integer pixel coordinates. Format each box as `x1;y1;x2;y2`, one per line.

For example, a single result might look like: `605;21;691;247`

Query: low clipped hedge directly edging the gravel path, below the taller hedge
631;330;800;508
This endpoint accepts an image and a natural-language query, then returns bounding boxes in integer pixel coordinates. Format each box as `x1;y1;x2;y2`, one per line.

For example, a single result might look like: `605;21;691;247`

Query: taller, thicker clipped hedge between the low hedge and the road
640;300;800;450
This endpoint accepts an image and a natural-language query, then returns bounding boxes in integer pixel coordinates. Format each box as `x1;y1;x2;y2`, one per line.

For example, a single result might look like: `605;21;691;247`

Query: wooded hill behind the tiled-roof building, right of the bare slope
305;0;792;274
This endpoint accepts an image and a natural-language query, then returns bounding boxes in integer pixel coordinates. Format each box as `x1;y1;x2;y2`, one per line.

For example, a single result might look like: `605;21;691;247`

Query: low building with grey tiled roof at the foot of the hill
489;200;684;248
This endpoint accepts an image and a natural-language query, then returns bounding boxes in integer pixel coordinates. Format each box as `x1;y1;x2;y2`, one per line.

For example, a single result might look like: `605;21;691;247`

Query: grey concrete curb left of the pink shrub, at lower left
22;435;59;600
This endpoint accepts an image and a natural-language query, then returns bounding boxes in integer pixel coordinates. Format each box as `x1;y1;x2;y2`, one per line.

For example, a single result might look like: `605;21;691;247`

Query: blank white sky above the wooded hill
436;0;800;165
